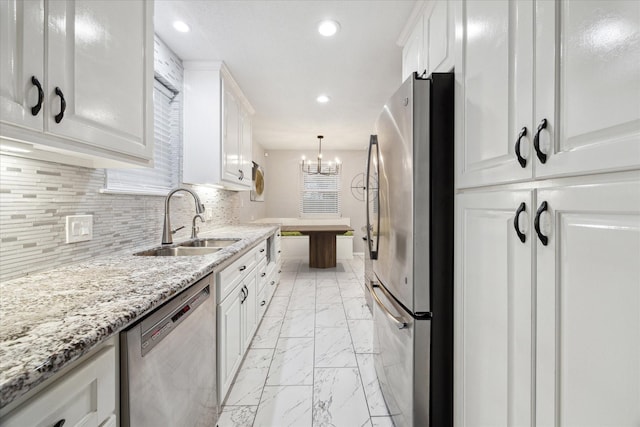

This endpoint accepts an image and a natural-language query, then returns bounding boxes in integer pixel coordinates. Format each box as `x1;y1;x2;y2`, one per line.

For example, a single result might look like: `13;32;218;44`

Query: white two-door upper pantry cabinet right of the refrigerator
455;0;640;188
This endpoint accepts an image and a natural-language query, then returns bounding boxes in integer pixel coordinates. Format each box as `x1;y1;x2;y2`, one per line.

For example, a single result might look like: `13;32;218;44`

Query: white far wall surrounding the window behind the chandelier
264;149;367;252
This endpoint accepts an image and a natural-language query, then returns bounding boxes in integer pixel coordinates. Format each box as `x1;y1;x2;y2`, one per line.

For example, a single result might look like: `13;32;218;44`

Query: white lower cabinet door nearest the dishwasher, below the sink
218;286;244;403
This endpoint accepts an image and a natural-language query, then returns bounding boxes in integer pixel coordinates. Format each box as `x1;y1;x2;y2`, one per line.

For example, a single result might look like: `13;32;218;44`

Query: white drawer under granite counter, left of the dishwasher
0;346;116;427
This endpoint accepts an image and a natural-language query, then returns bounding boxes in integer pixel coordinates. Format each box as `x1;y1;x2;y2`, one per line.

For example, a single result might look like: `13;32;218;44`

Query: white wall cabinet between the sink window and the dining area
183;61;254;190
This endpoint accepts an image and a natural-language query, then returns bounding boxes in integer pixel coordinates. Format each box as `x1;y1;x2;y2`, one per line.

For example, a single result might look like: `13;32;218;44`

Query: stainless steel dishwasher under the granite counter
120;274;218;427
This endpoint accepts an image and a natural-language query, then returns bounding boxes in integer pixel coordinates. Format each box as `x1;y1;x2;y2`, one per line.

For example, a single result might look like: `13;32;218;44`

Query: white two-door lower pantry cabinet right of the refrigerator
455;173;640;427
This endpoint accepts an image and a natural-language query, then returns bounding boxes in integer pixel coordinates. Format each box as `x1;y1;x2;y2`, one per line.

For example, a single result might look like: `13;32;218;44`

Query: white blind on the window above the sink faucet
106;80;182;195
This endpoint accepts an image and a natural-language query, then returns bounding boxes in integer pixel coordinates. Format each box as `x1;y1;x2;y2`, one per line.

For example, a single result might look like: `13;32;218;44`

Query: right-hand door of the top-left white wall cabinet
45;0;153;159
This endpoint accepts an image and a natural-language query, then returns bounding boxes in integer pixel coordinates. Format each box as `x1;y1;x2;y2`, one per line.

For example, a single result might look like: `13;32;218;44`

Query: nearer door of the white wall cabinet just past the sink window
222;80;242;184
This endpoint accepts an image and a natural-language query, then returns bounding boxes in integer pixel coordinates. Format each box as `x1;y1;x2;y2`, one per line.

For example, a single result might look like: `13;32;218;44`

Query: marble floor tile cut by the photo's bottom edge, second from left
253;386;313;427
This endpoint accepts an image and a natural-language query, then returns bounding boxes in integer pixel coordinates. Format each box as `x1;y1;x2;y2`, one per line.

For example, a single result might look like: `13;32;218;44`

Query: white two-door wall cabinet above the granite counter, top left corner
0;0;153;167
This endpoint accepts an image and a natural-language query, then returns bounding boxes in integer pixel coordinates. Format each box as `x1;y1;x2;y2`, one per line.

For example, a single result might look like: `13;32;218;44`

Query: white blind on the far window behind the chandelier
299;172;340;217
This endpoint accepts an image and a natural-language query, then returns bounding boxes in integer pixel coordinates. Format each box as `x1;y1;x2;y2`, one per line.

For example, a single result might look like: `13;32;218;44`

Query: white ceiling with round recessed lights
154;0;416;150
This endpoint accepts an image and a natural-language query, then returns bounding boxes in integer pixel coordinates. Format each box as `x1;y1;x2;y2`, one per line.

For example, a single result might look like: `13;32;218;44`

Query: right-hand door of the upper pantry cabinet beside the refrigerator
535;0;640;177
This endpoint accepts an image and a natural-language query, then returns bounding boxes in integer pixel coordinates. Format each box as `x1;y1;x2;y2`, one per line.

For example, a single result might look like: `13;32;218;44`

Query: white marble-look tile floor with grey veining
218;256;393;427
